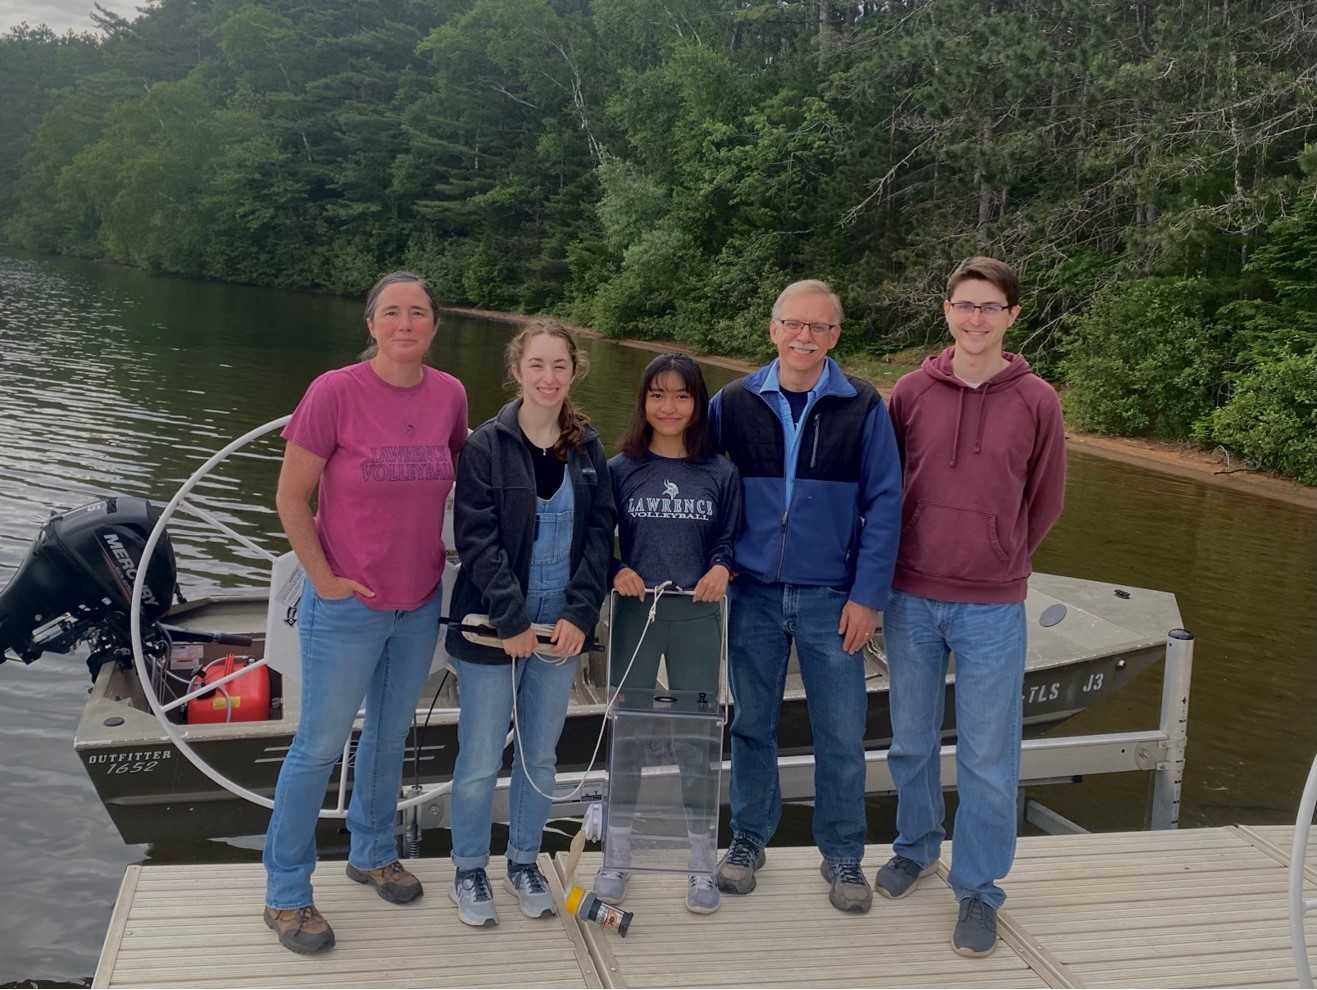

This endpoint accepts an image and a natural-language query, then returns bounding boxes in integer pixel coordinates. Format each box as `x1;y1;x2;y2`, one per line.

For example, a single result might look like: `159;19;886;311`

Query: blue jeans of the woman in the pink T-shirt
261;582;441;908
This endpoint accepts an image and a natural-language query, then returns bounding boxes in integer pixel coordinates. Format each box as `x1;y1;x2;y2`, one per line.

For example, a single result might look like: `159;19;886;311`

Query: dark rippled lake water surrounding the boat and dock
0;258;1317;985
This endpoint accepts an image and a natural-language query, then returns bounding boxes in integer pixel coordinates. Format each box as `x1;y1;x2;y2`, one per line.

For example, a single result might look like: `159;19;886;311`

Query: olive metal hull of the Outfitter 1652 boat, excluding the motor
61;574;1179;843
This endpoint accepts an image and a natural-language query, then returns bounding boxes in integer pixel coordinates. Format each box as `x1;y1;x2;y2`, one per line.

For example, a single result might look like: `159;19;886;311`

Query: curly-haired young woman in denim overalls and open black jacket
446;321;614;927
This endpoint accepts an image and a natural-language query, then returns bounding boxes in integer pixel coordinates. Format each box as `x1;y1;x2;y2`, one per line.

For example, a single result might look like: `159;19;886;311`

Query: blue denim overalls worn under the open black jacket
453;467;579;870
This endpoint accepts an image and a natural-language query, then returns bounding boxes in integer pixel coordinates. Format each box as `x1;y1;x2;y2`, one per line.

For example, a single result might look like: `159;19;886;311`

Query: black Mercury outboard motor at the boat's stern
0;495;176;677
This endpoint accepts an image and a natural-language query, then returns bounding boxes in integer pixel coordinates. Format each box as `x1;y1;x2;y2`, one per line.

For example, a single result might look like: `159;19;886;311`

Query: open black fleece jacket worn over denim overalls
445;399;615;664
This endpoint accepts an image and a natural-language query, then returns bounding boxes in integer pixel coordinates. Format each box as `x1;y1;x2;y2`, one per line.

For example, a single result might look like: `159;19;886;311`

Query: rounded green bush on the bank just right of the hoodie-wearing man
1062;279;1227;438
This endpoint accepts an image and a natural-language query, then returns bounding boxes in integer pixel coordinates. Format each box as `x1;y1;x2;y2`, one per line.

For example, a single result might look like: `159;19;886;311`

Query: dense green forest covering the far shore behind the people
0;0;1317;484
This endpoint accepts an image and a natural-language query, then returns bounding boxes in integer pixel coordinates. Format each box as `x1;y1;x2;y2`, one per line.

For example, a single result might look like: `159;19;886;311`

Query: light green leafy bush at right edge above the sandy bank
1195;350;1317;484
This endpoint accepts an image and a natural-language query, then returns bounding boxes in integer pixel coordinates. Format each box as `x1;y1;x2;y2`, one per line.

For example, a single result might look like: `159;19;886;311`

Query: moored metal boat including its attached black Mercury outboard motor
0;419;1180;843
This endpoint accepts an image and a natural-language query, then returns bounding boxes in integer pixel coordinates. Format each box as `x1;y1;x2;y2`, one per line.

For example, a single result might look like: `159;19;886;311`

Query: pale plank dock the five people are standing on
94;827;1317;987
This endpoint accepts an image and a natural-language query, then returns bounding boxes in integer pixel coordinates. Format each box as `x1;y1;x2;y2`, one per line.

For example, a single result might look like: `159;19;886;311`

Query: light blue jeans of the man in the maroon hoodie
882;591;1026;907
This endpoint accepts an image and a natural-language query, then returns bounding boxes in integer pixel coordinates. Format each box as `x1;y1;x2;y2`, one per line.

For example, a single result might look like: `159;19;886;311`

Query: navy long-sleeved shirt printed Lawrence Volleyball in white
608;453;741;591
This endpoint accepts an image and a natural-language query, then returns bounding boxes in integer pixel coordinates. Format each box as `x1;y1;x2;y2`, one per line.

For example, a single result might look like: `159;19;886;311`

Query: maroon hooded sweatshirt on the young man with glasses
888;348;1065;603
